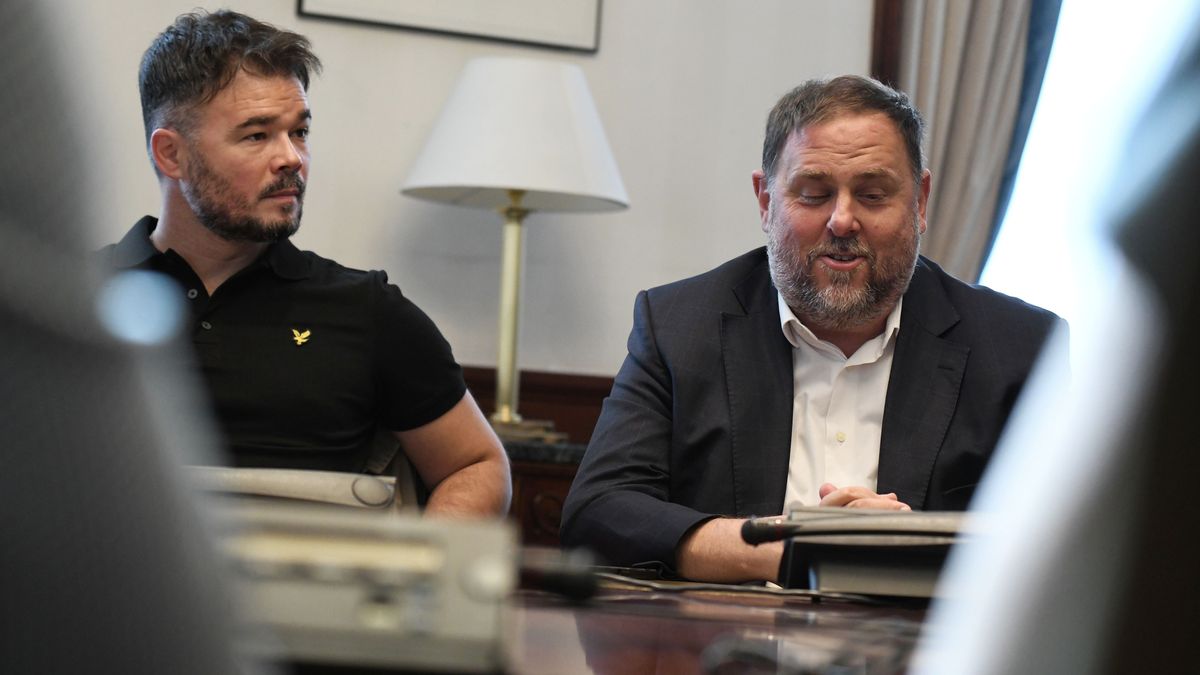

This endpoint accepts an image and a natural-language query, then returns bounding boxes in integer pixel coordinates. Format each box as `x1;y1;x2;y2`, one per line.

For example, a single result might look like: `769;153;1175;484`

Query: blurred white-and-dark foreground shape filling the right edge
913;10;1200;674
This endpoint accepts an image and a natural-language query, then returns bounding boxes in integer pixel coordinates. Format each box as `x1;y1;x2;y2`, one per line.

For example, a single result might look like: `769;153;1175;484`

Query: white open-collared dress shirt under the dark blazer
779;295;904;509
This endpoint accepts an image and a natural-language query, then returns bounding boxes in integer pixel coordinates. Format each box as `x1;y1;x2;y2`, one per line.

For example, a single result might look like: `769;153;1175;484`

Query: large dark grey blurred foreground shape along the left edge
0;0;253;675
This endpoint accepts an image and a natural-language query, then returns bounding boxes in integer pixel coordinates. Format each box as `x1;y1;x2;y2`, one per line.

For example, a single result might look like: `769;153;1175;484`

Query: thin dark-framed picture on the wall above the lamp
296;0;601;53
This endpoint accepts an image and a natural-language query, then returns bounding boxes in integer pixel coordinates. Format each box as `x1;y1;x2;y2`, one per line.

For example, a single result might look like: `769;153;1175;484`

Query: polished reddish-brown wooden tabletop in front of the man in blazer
506;571;924;675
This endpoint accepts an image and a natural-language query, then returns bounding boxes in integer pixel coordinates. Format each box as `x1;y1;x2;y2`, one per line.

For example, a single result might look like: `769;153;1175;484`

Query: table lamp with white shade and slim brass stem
401;56;629;440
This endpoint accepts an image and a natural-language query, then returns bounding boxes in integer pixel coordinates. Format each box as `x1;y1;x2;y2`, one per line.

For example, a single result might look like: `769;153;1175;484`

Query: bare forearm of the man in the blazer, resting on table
676;518;784;584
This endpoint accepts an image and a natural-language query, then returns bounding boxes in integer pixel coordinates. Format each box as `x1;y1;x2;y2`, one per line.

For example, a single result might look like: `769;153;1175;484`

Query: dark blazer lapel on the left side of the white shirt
721;259;792;515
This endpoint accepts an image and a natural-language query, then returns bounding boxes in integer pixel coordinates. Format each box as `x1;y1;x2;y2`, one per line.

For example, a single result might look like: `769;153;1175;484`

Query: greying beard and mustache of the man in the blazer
767;206;920;330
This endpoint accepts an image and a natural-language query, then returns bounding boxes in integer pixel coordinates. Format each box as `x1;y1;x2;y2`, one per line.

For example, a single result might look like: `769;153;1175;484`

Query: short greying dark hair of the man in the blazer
762;74;925;186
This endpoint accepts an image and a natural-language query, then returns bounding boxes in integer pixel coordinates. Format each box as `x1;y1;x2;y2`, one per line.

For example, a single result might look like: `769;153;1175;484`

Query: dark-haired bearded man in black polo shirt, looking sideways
103;11;511;515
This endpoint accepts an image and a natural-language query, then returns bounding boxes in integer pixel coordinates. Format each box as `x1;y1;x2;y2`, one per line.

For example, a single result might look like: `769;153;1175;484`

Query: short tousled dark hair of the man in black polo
138;10;320;157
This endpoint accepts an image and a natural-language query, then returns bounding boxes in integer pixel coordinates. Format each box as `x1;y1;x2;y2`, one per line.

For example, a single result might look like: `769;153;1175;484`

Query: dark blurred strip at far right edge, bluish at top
1096;18;1200;673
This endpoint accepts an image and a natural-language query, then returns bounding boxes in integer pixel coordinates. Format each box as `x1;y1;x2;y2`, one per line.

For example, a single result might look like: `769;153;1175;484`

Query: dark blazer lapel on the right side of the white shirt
877;258;970;508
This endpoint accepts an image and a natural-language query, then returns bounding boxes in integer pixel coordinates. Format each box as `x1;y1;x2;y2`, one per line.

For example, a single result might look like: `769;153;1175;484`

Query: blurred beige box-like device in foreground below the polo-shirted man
212;497;517;673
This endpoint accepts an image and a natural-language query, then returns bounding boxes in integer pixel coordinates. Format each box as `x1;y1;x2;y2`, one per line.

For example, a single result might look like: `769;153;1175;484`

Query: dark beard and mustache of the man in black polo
182;151;305;243
